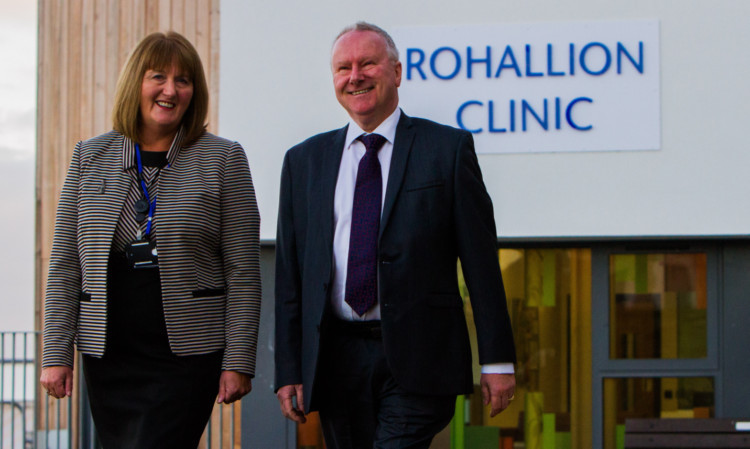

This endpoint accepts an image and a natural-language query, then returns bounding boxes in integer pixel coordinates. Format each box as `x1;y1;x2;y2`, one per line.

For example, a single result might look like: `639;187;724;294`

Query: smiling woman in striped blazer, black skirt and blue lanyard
41;32;261;449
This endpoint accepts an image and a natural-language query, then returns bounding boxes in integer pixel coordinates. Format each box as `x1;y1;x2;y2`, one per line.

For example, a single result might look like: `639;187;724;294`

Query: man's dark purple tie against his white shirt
345;134;386;316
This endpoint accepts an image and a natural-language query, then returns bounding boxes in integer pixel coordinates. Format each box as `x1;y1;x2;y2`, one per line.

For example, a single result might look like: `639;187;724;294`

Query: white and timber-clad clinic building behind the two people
37;0;750;449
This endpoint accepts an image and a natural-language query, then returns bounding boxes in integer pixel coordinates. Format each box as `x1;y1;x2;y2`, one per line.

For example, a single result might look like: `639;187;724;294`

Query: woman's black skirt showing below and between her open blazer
83;254;223;449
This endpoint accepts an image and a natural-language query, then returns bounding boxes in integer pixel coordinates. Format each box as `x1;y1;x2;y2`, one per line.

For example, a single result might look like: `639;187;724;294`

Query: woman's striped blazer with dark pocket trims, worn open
42;131;261;376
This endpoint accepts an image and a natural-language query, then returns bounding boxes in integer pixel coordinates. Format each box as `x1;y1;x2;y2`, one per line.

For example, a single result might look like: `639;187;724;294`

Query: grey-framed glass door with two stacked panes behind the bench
592;246;720;449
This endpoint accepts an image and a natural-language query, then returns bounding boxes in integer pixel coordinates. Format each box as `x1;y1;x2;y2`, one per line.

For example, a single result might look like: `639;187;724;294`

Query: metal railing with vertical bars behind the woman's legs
0;332;240;449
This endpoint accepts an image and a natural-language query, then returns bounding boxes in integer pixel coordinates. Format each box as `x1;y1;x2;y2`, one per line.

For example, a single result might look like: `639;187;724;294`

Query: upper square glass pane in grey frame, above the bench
610;253;707;359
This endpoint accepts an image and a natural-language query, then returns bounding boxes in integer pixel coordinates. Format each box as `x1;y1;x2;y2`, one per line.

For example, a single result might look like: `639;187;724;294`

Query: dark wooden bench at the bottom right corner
625;418;750;449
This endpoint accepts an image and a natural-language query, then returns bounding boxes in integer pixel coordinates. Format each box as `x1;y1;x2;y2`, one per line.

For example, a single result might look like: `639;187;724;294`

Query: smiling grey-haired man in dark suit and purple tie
275;22;515;449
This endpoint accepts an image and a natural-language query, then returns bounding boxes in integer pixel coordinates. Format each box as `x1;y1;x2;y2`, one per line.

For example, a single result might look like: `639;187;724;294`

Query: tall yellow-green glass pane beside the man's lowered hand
458;249;591;448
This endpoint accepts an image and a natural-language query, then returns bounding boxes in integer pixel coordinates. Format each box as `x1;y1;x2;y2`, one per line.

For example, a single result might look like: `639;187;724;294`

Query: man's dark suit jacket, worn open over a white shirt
275;113;515;409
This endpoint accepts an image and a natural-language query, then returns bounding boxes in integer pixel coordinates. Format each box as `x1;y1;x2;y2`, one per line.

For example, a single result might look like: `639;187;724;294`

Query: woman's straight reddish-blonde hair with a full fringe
112;31;208;145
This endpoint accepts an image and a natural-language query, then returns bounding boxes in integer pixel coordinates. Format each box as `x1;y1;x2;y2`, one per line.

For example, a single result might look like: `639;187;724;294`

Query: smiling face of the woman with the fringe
141;65;193;133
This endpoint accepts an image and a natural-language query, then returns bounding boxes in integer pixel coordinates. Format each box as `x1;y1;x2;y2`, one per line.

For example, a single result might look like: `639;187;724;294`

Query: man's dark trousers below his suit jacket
316;325;456;449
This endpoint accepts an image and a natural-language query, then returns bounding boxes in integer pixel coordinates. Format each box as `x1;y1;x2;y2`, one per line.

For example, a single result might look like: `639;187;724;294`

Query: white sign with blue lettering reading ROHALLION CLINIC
393;20;661;153
